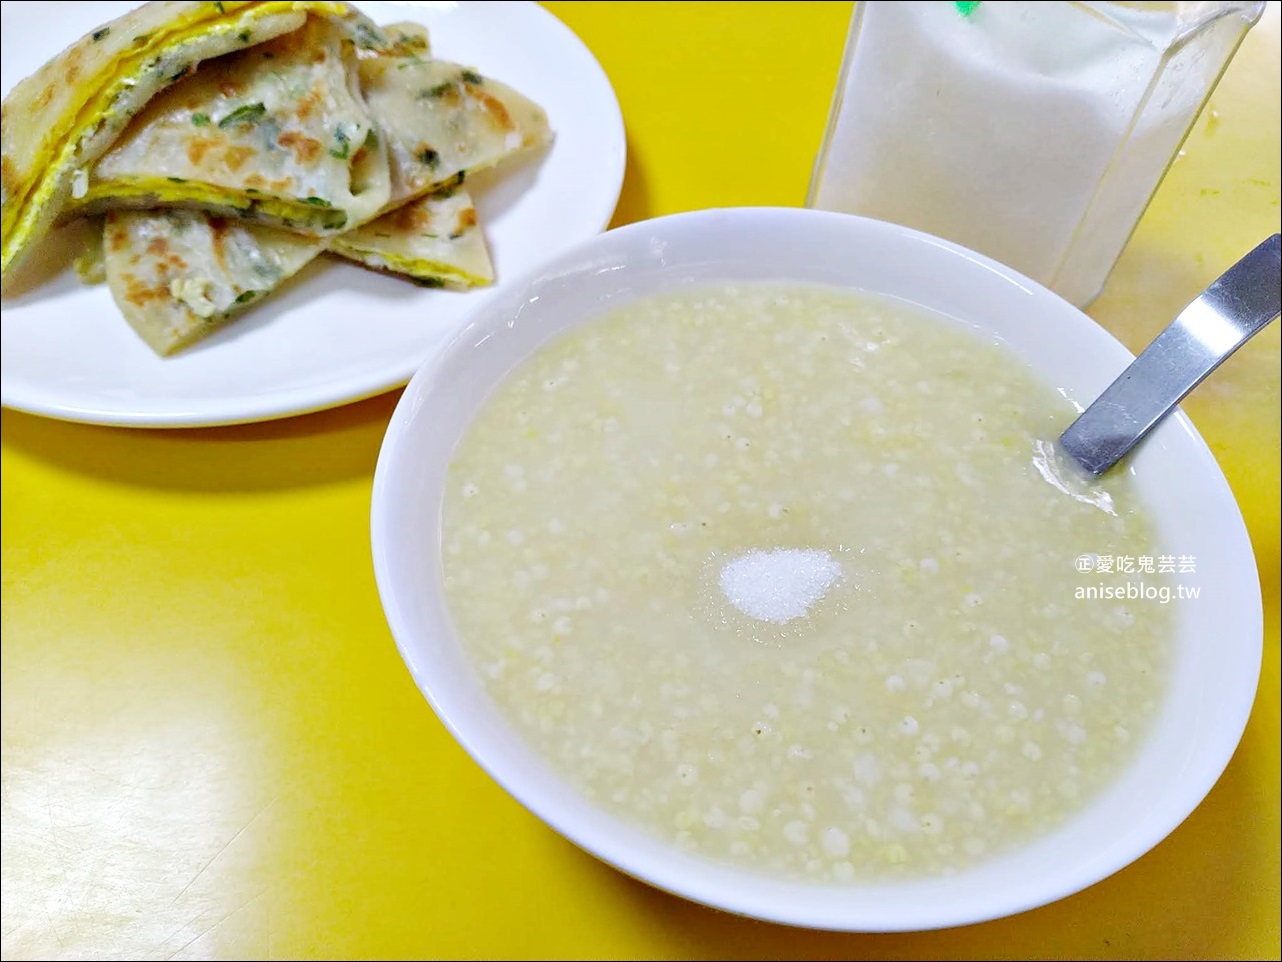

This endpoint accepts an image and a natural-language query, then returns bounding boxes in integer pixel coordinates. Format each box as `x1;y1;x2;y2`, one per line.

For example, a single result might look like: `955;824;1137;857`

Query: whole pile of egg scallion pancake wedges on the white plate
3;0;551;355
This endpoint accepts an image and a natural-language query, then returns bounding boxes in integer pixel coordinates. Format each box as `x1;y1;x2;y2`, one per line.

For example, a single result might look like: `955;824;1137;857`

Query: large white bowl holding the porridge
372;208;1263;931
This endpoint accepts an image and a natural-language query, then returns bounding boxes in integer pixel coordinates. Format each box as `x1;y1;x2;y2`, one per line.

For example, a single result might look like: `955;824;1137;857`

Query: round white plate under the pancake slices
0;1;626;427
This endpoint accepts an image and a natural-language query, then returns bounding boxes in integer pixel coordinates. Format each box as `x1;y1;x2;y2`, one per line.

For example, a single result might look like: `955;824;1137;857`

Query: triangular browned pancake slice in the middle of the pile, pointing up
79;17;390;235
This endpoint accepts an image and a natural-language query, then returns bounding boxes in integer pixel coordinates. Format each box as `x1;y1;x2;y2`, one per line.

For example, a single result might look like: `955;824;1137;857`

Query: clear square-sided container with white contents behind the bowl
808;0;1264;307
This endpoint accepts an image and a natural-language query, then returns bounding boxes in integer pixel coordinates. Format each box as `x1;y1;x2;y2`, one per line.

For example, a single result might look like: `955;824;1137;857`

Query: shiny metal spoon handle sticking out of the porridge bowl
1059;233;1282;475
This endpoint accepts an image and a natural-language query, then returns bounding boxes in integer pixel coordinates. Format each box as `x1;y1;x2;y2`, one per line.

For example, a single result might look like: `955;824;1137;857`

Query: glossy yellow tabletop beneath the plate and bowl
0;3;1279;959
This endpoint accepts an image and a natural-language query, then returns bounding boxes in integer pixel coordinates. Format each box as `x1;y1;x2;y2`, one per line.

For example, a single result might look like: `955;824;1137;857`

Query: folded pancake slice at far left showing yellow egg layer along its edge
0;0;368;282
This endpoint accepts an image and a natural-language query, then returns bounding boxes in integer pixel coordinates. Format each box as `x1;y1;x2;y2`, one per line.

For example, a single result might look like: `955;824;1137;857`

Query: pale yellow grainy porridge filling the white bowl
441;283;1173;882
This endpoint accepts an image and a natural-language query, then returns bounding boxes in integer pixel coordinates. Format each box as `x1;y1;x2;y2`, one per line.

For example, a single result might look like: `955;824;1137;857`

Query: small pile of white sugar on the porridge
719;548;841;625
